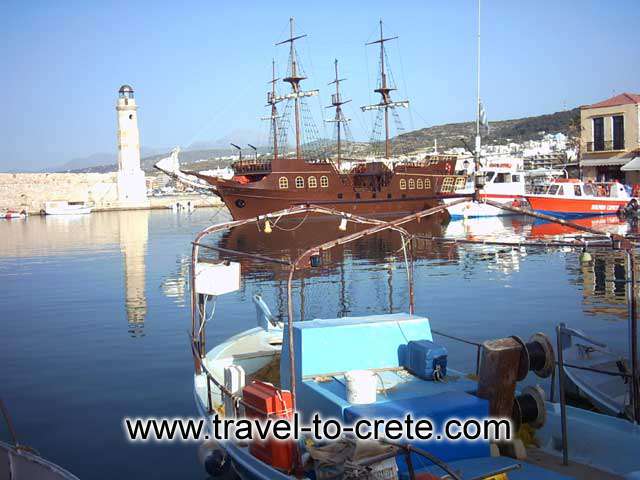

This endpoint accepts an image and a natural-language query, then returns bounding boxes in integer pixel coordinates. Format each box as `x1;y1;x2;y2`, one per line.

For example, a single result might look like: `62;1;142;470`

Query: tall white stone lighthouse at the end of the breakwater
116;85;148;207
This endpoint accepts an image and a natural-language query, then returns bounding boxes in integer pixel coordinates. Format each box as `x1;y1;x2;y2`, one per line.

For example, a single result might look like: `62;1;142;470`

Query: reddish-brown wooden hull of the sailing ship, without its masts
189;159;464;220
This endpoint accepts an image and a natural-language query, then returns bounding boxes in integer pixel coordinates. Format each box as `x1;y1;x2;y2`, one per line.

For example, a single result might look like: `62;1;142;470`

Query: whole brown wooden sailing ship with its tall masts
165;18;465;220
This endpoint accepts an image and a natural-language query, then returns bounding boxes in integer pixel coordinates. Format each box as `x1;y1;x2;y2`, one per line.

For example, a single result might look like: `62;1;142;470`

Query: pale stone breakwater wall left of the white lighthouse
0;173;118;213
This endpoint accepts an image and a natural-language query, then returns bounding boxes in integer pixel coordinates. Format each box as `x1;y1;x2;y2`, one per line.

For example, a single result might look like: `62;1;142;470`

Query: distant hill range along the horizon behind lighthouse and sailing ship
63;108;580;173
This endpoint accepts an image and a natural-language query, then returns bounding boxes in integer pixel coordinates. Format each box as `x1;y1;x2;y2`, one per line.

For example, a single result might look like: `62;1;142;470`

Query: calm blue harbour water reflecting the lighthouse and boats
0;209;628;479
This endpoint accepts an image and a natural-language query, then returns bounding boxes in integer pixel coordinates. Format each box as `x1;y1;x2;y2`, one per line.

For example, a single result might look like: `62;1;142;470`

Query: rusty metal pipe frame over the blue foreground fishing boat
190;196;640;480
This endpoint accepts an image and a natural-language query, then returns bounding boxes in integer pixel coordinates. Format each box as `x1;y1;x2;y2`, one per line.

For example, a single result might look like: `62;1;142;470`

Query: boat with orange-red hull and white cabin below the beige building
525;178;633;217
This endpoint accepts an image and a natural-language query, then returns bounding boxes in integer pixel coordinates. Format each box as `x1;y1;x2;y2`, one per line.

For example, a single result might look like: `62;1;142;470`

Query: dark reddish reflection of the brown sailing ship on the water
202;217;457;319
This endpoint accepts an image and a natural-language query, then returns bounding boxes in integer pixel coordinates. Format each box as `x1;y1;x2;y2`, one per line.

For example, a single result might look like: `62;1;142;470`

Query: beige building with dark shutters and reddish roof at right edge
580;93;640;185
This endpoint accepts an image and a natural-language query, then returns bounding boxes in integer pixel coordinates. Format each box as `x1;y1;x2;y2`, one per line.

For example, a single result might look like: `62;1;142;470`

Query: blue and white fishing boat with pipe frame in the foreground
184;203;640;479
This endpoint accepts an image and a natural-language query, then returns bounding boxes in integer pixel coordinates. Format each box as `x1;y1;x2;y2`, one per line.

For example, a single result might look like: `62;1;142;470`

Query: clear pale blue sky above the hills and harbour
0;0;640;171
